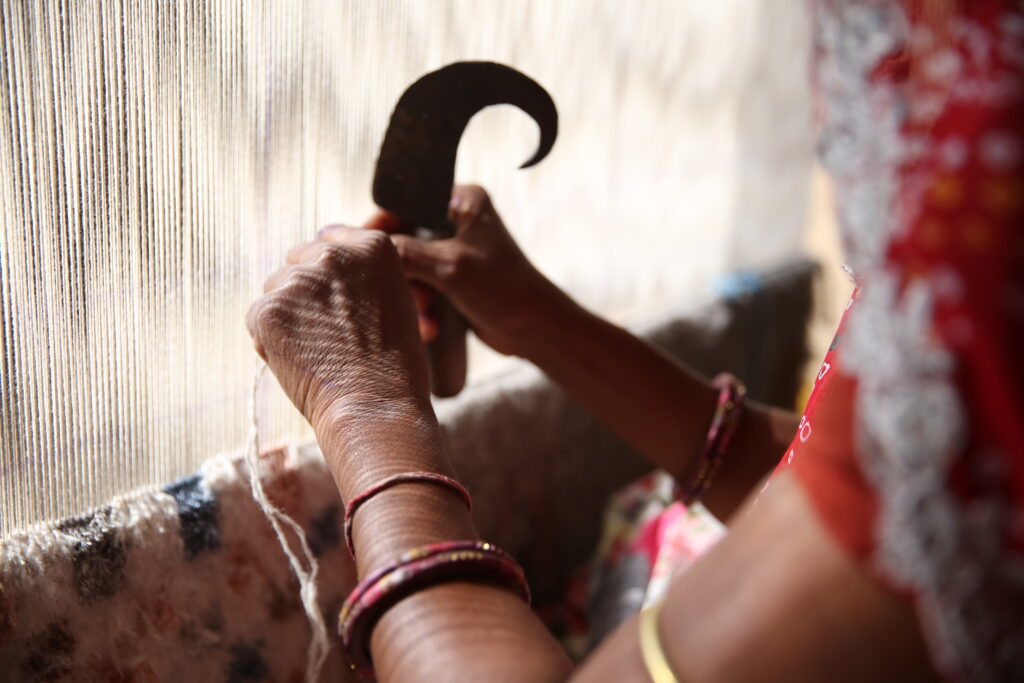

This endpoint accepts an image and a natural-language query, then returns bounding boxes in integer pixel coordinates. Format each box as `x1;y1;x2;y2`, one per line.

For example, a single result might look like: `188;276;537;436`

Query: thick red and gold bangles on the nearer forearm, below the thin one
338;541;529;679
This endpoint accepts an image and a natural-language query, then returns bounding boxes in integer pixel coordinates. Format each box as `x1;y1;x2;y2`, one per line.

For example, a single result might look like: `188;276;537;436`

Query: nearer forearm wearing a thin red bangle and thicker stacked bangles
318;403;570;681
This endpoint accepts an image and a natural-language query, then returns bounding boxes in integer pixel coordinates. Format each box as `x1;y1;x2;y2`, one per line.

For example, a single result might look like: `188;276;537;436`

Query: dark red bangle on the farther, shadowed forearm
680;373;746;506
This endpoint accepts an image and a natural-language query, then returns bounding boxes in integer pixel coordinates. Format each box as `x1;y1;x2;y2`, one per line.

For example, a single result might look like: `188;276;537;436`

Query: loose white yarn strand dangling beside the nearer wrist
246;361;331;681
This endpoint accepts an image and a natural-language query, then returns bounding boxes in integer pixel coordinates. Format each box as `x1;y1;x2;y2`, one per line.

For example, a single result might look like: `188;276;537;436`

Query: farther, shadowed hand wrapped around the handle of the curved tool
319;185;564;355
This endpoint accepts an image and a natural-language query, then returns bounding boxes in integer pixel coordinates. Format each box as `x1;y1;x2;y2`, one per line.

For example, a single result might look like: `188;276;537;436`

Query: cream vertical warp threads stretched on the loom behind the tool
0;0;813;535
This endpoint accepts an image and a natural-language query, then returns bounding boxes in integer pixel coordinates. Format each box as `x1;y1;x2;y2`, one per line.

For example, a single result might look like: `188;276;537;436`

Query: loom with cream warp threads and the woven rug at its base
0;0;814;681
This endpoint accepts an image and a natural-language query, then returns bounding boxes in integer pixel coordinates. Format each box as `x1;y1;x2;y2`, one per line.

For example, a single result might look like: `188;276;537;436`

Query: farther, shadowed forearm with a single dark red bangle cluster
522;291;797;518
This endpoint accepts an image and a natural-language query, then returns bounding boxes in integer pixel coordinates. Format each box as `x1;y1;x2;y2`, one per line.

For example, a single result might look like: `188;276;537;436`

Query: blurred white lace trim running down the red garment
816;0;1024;681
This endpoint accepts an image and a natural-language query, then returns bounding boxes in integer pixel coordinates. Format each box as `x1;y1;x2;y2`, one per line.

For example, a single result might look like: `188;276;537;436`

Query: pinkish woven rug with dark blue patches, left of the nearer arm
0;447;355;683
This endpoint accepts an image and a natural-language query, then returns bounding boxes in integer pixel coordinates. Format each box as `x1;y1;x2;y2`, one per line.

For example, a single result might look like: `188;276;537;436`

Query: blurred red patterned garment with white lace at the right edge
780;0;1024;681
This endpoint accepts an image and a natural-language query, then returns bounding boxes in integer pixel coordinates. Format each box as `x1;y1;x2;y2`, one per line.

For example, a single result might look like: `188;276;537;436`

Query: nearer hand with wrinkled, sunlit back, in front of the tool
246;227;429;435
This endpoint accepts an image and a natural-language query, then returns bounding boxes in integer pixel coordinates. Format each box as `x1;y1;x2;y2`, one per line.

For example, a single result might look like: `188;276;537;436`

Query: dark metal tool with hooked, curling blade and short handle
373;61;558;396
